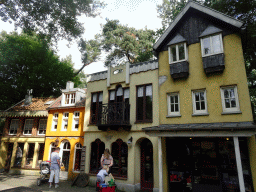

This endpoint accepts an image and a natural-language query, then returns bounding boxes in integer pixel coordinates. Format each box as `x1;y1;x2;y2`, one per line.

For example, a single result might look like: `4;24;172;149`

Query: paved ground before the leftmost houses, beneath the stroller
0;174;96;192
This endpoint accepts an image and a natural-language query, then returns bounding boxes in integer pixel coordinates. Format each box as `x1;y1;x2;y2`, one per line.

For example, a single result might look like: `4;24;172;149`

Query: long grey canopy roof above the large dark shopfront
142;122;256;137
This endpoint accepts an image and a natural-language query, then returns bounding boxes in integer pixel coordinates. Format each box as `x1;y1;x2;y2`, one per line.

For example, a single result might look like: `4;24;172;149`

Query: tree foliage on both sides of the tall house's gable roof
158;0;256;114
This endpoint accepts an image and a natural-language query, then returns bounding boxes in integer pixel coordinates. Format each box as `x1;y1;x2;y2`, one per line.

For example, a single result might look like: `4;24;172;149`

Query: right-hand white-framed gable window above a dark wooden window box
201;34;223;56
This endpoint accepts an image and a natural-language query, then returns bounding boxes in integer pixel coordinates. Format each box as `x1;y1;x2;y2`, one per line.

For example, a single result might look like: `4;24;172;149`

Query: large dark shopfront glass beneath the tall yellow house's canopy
166;138;253;192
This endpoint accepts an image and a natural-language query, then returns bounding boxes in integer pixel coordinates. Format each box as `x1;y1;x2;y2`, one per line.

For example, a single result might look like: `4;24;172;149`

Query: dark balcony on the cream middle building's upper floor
97;102;131;131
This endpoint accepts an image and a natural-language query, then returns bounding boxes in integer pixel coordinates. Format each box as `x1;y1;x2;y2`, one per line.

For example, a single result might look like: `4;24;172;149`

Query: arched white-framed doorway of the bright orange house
60;141;70;180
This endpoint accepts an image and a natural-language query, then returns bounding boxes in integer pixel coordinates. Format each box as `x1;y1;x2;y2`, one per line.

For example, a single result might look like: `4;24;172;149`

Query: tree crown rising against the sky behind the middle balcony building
87;19;156;66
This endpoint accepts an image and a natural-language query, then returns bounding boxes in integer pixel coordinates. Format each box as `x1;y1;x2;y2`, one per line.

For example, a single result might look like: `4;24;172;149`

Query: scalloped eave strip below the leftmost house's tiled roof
0;111;48;117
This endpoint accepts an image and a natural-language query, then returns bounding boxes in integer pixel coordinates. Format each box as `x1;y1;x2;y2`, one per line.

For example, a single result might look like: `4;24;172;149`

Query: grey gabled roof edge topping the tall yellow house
153;1;243;50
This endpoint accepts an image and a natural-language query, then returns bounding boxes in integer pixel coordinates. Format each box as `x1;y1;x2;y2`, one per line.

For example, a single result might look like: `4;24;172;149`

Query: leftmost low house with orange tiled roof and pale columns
0;94;55;175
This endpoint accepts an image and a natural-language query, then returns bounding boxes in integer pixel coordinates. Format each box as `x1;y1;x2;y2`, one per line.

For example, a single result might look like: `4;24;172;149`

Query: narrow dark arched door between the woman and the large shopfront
140;139;154;191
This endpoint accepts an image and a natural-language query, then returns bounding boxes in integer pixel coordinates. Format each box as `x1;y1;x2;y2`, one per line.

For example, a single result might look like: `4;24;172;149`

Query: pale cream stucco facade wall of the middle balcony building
84;65;159;188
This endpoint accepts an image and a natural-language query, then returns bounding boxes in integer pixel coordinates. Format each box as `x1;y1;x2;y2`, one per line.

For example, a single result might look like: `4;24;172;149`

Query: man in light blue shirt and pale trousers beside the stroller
49;147;60;188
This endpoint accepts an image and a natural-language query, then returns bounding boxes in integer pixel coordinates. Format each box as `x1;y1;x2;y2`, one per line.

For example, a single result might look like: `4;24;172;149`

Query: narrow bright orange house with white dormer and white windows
43;81;86;180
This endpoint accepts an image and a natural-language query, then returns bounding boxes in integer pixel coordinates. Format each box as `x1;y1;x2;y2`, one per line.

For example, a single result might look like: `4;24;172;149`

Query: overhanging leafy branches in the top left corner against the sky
0;0;103;41
